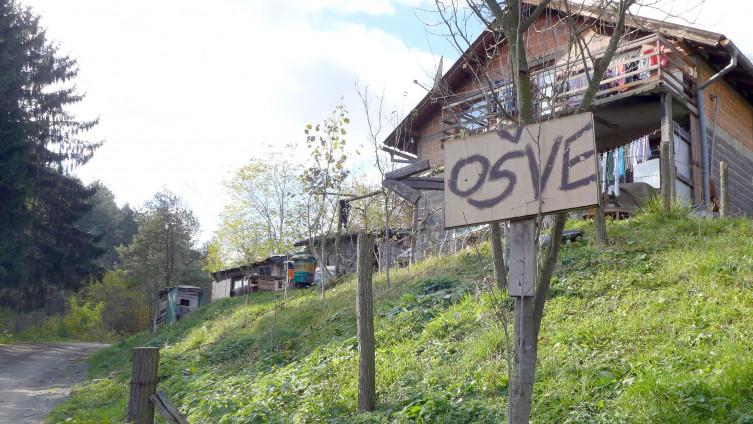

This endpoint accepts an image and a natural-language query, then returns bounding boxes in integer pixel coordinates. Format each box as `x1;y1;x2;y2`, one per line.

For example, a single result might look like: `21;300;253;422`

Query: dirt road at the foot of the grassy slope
0;343;107;424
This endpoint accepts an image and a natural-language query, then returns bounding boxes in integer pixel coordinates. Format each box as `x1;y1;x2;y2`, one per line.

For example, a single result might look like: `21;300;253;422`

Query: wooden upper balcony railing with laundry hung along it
442;34;696;140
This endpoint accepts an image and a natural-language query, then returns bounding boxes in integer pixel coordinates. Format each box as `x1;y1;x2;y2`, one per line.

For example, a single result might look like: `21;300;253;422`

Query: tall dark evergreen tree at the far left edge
0;0;101;309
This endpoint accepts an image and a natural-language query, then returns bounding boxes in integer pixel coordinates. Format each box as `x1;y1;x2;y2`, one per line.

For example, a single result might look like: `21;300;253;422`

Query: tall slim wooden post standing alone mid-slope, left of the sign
356;234;376;411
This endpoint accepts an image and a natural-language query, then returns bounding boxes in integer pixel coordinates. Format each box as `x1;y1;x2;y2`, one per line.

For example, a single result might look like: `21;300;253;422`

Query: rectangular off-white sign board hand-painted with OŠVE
444;112;599;228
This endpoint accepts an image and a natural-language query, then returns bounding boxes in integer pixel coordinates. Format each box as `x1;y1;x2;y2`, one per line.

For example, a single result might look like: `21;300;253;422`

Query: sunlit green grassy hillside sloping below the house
50;205;753;423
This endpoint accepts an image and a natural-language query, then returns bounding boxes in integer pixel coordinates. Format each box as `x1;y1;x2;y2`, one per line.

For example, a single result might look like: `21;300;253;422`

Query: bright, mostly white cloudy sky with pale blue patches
21;0;753;241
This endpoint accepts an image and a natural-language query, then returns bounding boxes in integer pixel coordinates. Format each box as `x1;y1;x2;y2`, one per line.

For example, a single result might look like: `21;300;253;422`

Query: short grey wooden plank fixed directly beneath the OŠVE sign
508;219;536;297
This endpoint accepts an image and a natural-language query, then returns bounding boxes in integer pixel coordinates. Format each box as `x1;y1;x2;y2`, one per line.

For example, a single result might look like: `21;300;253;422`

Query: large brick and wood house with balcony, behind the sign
384;0;753;251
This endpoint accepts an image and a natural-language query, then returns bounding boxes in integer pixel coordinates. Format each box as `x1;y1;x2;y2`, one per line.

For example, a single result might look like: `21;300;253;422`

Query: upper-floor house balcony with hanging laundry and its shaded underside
442;34;697;151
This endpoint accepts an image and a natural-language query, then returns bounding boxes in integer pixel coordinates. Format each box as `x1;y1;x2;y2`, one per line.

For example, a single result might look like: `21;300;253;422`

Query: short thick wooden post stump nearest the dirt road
126;347;159;424
